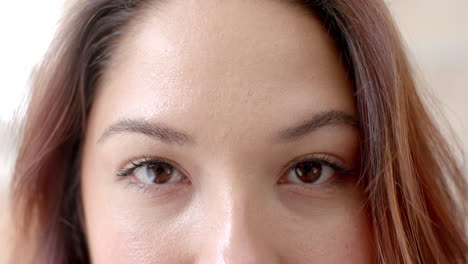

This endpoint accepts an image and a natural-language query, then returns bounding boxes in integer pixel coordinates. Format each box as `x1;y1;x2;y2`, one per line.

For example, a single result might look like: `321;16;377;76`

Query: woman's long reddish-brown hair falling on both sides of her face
11;0;468;264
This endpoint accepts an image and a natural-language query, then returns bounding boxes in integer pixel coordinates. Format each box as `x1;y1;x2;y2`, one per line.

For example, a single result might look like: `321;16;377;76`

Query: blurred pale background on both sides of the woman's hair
0;0;468;263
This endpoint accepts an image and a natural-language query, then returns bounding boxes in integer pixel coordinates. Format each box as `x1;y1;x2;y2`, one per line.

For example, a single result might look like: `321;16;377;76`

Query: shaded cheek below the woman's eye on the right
276;182;375;264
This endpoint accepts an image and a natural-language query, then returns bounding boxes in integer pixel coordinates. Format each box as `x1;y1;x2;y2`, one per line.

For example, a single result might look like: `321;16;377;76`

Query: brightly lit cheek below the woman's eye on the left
84;203;194;264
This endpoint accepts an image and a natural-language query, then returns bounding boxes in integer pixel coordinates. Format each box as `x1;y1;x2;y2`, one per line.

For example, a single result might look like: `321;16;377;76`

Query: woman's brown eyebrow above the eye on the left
97;119;194;145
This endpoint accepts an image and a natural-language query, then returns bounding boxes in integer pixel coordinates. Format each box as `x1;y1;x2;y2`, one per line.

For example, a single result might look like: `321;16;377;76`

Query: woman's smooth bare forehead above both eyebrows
97;0;354;140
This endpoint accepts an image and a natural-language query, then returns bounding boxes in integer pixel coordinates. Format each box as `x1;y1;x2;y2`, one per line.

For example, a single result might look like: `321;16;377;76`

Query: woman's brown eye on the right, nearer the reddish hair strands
286;161;336;184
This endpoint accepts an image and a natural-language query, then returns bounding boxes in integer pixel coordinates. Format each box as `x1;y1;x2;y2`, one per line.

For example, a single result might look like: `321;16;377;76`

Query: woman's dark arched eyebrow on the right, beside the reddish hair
275;110;359;142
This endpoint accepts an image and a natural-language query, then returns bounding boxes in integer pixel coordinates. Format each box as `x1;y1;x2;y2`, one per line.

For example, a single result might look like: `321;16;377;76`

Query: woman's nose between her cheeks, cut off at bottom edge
197;185;279;264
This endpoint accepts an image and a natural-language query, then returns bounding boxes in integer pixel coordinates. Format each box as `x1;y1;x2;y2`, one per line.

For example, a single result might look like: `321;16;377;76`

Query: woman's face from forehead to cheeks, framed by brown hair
81;0;373;264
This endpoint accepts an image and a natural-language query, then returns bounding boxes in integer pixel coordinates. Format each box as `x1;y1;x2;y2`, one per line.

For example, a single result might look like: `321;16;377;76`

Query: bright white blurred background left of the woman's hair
0;0;64;185
